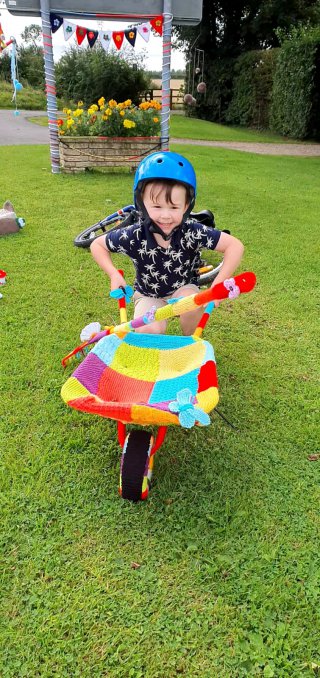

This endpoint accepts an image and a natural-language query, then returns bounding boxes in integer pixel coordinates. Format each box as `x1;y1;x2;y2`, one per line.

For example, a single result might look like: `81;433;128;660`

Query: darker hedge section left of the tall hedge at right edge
225;49;279;129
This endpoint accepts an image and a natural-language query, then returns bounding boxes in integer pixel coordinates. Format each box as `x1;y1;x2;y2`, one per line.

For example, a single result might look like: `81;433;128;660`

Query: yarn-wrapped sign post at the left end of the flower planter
40;0;60;174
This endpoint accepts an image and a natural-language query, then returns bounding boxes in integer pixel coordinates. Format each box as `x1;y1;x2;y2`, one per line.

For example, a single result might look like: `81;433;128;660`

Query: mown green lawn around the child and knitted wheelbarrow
0;146;320;678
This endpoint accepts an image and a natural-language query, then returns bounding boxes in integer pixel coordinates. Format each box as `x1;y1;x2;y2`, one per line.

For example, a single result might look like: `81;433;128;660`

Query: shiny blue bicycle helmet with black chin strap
133;151;197;240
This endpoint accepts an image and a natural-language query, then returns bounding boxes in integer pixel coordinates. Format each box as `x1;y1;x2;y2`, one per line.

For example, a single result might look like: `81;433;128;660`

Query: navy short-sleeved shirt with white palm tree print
105;219;221;299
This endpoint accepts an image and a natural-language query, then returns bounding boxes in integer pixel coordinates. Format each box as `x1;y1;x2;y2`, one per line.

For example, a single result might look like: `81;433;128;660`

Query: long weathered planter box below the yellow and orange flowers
59;137;160;172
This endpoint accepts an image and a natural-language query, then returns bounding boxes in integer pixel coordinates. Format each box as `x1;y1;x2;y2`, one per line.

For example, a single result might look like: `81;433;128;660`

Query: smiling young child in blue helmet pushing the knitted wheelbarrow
91;151;244;335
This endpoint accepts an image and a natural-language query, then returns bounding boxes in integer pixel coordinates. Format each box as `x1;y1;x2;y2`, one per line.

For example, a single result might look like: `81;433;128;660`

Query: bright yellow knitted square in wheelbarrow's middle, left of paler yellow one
110;342;159;381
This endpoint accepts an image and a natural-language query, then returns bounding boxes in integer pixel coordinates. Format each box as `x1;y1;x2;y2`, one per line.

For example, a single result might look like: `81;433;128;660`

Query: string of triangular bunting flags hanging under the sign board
50;12;163;52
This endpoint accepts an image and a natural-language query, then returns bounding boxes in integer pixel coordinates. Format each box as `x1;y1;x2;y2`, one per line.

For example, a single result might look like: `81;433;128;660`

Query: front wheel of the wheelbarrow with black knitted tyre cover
119;430;153;502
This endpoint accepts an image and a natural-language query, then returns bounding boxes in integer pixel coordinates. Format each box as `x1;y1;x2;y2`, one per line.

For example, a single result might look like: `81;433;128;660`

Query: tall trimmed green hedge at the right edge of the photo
271;28;320;139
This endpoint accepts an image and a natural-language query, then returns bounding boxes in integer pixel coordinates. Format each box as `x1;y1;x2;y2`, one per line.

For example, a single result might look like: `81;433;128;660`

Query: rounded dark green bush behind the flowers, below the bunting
55;46;149;106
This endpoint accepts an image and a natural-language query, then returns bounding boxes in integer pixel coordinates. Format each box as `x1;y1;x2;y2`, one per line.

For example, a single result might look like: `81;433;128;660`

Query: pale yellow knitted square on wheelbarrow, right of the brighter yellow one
158;342;206;380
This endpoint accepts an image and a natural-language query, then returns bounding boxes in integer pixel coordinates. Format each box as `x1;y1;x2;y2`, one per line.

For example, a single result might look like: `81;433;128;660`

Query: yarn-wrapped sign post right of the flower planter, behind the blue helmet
161;0;172;151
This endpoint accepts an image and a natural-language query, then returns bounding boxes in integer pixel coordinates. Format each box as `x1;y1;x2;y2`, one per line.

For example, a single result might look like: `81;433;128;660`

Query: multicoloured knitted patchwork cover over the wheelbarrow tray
61;332;219;426
